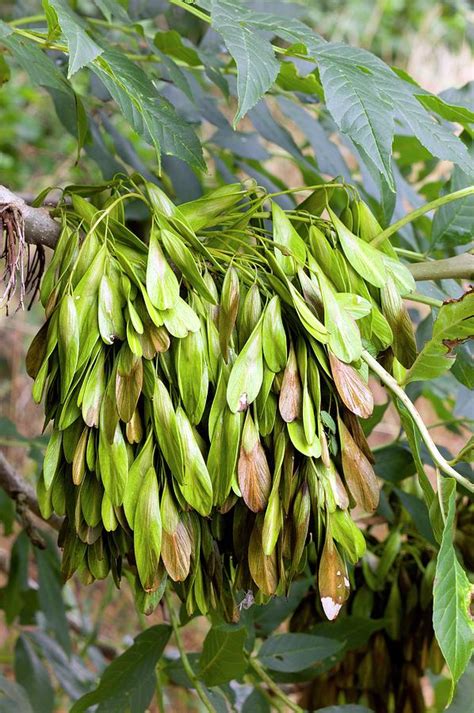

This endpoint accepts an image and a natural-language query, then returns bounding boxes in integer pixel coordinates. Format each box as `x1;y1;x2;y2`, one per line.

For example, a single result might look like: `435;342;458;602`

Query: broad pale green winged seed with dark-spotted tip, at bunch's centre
227;318;263;413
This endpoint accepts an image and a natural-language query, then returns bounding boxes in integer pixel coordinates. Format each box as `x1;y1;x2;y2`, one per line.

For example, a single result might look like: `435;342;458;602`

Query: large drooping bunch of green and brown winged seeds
27;180;416;619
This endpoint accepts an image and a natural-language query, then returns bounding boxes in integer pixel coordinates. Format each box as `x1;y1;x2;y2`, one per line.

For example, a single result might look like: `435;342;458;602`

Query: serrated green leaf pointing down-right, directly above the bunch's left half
91;49;205;170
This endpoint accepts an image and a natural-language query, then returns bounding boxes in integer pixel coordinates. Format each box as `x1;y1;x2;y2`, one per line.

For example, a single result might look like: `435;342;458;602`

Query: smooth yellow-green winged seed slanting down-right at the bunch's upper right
328;208;386;287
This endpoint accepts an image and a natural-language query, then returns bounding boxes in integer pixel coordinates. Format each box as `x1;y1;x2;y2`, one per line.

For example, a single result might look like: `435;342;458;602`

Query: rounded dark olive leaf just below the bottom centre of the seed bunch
199;624;247;686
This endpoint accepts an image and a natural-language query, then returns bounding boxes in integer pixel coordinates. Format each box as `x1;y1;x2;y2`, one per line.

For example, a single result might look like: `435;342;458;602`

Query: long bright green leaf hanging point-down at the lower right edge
433;480;474;700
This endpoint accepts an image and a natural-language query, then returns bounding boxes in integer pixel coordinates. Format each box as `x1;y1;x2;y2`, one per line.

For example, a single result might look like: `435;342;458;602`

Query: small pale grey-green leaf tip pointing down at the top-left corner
43;0;104;78
